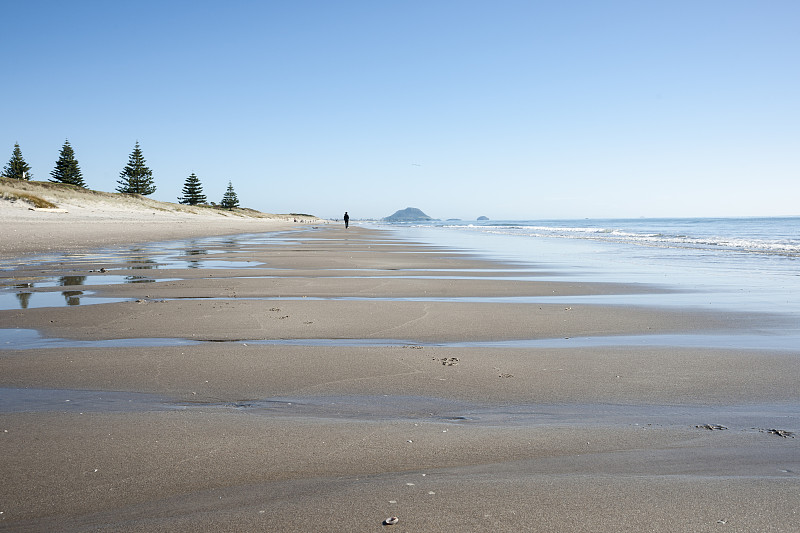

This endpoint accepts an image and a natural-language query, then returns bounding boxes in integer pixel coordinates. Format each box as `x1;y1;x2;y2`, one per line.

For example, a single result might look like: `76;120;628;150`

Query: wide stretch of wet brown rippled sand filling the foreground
0;226;800;532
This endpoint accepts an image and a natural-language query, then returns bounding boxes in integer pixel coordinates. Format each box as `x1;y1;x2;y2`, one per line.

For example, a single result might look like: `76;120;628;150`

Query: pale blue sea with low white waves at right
378;217;800;320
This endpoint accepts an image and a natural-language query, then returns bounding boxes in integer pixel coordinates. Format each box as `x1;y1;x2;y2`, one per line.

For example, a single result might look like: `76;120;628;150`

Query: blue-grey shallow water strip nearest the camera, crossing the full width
0;388;800;438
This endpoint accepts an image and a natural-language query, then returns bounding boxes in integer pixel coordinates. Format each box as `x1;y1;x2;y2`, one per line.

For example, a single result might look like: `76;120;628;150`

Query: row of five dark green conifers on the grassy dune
2;139;239;209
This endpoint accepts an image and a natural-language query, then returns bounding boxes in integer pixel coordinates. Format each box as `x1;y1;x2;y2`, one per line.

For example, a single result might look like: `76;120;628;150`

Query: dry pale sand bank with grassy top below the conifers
0;178;322;258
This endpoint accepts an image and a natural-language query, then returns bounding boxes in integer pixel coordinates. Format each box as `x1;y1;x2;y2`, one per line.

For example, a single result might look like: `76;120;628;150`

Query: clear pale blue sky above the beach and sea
0;0;800;219
